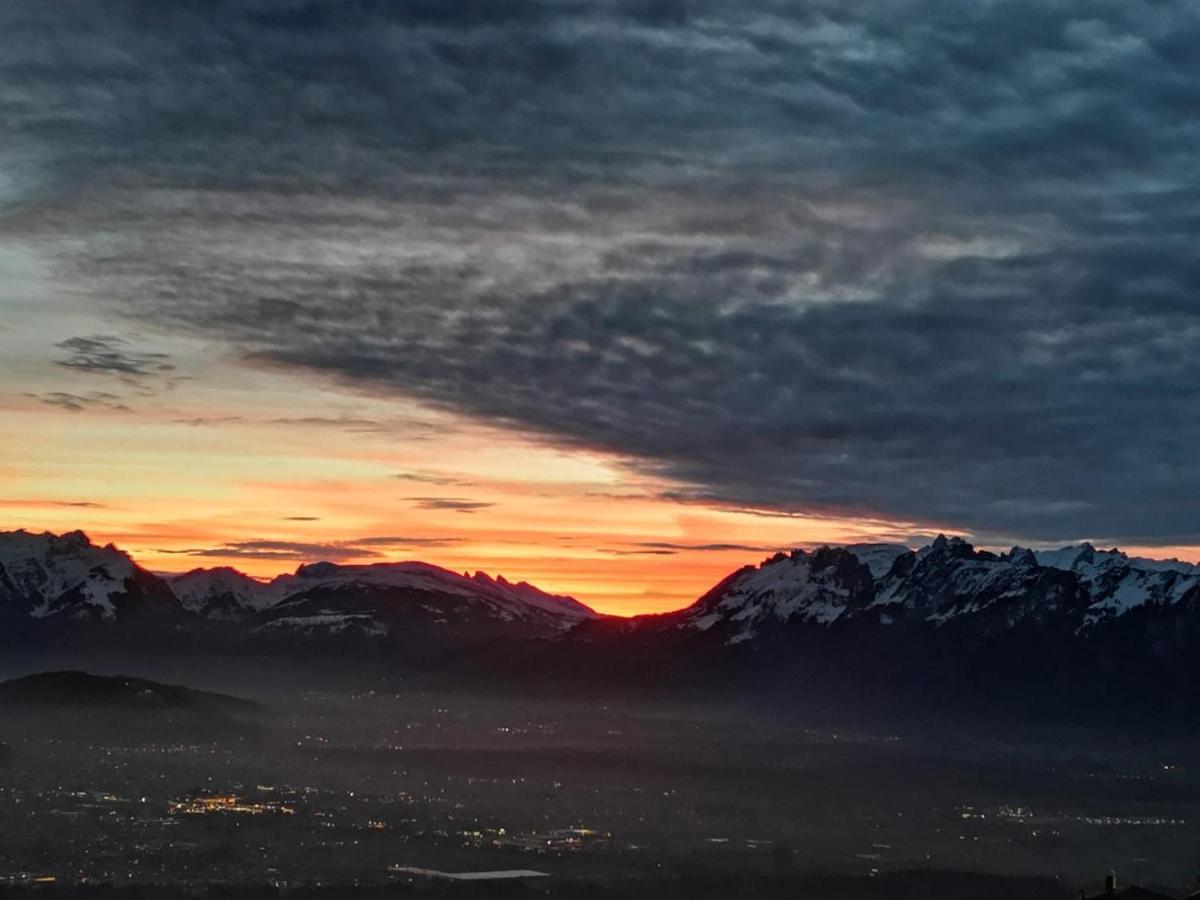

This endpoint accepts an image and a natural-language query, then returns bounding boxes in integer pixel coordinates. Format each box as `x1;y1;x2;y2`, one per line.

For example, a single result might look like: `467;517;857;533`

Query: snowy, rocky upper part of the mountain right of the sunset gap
672;536;1200;644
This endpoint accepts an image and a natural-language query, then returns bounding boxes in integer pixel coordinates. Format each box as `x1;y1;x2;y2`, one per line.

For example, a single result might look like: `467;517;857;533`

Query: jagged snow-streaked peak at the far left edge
0;530;179;622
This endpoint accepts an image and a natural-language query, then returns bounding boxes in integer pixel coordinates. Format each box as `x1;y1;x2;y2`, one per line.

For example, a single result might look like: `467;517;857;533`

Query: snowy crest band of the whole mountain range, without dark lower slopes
9;529;1200;642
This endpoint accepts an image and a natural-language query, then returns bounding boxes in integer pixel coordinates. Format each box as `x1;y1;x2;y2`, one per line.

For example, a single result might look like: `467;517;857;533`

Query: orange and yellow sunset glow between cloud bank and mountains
0;350;940;616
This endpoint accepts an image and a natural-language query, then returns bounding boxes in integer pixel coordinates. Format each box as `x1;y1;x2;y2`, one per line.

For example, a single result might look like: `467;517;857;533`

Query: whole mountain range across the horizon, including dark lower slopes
0;530;1200;724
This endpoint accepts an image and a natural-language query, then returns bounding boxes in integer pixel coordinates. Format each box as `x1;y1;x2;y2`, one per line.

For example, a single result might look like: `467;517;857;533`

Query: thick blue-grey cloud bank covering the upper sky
9;0;1200;550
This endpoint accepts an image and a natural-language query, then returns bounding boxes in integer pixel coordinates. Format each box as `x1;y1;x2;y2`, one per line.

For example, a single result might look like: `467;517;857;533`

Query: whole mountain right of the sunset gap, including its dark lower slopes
523;536;1200;727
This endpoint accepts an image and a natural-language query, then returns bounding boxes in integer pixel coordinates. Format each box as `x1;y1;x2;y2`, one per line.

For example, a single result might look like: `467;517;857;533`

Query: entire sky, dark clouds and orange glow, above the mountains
0;0;1200;613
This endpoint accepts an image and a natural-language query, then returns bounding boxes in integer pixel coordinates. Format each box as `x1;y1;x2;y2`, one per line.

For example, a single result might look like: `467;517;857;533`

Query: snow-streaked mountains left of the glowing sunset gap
0;532;598;643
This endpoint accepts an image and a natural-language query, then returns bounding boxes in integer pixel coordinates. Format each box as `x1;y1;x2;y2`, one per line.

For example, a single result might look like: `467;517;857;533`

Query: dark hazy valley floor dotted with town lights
0;671;1200;900
